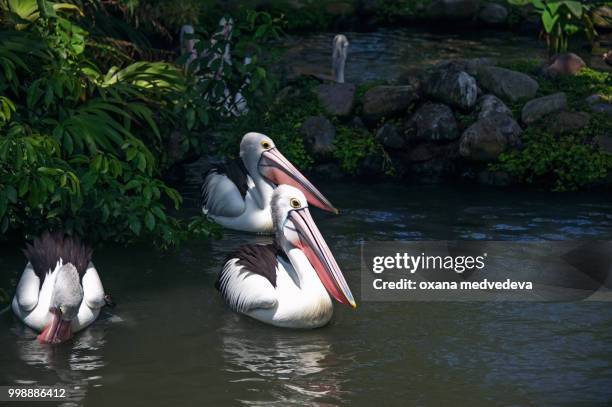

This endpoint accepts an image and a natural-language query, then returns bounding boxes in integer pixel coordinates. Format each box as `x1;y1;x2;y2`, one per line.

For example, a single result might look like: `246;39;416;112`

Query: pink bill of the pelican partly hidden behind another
259;148;338;214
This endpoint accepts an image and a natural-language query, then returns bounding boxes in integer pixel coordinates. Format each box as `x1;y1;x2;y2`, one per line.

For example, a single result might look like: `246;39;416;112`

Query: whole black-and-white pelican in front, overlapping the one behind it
216;185;356;328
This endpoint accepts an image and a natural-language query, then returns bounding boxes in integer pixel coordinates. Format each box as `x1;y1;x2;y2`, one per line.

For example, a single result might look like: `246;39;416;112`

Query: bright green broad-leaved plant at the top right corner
508;0;597;54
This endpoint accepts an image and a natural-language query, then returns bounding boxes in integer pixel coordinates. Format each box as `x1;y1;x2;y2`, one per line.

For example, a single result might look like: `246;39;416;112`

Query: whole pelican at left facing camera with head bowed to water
11;232;106;344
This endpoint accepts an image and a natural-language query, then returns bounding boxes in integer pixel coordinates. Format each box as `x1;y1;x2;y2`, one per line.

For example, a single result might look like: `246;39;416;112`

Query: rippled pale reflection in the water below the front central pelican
220;317;344;406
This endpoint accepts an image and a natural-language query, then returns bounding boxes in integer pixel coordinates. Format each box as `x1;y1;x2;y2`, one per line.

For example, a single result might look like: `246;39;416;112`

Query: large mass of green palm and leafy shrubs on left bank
0;1;220;247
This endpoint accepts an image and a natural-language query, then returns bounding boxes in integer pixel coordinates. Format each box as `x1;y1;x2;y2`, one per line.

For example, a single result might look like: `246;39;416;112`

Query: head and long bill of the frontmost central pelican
272;185;357;308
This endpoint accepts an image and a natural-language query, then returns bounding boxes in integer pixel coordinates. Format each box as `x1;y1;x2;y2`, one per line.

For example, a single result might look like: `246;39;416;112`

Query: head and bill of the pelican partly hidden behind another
240;132;338;213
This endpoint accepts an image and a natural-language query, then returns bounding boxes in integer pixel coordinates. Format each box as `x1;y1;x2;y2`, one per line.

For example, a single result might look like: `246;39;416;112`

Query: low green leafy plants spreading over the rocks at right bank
493;117;612;191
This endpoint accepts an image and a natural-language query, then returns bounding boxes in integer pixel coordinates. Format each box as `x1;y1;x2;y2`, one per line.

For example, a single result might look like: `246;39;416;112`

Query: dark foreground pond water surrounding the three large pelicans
0;182;612;406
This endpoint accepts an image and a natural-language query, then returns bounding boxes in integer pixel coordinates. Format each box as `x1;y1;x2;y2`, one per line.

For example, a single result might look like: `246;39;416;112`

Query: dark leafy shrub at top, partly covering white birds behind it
177;10;282;130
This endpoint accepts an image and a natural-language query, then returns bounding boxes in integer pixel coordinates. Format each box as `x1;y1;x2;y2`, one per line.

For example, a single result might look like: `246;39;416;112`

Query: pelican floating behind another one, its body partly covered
202;133;338;233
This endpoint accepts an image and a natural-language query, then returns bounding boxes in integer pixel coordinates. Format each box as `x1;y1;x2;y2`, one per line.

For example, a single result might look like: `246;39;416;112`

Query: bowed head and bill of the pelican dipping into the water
38;261;83;344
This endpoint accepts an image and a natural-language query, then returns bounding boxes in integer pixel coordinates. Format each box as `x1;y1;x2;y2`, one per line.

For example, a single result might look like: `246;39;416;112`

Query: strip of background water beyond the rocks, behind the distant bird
282;28;547;83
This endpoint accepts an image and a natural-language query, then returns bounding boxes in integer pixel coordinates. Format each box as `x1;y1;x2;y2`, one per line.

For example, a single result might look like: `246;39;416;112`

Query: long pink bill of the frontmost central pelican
288;208;357;308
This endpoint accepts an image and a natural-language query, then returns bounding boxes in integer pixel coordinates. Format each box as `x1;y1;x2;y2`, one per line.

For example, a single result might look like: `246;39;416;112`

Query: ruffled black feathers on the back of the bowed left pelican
23;232;93;285
